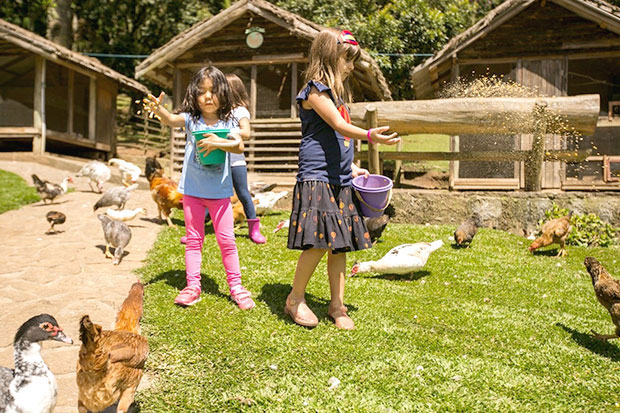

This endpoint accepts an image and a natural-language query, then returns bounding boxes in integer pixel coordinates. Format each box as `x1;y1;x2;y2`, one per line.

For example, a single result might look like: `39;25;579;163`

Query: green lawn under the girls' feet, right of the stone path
137;213;620;412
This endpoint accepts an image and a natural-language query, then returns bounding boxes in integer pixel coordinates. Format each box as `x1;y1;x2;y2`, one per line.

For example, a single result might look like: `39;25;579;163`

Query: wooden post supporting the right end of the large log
525;102;547;191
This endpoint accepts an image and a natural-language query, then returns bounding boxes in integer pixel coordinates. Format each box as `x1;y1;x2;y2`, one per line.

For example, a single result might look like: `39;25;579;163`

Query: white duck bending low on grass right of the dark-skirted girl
350;240;443;275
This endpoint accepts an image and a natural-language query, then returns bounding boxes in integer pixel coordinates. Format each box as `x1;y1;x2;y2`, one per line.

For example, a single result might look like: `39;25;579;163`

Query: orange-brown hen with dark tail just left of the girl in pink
144;157;183;227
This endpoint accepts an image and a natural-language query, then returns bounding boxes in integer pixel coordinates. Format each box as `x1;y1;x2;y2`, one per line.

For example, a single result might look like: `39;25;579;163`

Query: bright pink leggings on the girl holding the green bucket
183;195;241;289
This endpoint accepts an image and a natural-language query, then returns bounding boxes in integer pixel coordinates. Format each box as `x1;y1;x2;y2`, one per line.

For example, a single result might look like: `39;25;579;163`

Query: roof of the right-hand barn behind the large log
411;0;620;99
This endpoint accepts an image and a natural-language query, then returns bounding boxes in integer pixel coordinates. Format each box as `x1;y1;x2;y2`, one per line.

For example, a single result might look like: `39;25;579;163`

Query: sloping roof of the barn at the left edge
0;19;148;93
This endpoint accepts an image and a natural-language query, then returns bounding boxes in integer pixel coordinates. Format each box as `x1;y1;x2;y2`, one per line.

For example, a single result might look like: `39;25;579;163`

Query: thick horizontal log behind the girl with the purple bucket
351;95;600;135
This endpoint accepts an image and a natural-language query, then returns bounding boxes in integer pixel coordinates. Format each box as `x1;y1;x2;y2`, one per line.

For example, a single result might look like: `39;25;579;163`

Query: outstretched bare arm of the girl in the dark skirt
302;88;400;145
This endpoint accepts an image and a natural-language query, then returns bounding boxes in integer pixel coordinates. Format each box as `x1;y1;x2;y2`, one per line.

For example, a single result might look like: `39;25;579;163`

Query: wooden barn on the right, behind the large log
411;0;620;190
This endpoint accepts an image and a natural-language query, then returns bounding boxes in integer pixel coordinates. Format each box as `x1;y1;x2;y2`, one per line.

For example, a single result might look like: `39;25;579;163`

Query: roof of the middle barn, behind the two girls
135;0;392;100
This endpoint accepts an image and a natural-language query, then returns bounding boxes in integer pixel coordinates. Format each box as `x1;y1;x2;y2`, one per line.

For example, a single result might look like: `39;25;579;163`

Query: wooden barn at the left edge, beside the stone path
0;20;148;158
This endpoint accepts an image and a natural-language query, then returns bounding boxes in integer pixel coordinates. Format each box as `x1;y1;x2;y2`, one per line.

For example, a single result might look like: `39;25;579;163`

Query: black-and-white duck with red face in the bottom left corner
0;314;73;413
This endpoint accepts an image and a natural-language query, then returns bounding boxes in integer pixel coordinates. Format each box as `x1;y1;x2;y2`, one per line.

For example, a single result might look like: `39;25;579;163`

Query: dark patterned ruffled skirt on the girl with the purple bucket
288;181;372;252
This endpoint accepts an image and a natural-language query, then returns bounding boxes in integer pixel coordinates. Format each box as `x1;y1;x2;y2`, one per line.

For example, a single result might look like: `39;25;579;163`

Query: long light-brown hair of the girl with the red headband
304;28;361;103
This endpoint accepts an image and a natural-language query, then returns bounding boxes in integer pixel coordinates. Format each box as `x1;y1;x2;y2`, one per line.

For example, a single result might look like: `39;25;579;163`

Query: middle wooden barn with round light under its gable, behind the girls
136;0;391;174
